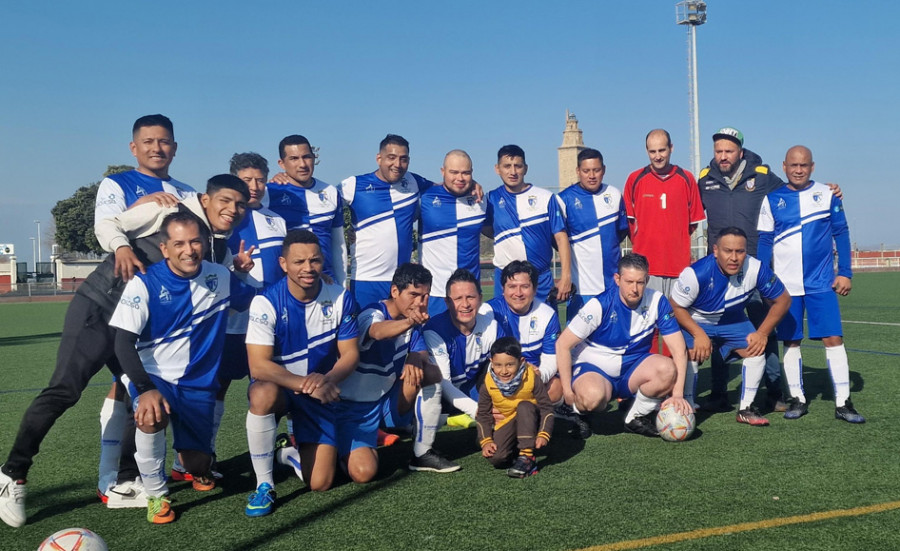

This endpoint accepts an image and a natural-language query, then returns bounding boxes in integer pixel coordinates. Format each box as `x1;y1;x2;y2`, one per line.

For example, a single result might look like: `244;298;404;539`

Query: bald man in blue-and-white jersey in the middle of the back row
419;149;486;316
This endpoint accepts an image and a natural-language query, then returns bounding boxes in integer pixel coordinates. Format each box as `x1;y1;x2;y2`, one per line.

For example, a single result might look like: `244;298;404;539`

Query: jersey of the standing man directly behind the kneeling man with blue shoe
263;178;347;285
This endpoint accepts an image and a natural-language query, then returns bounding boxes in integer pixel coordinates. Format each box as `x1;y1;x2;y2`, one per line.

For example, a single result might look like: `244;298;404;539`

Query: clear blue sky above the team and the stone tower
0;0;900;264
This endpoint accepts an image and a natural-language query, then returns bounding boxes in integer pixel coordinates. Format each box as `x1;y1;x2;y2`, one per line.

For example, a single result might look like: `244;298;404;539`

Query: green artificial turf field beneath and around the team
0;273;900;551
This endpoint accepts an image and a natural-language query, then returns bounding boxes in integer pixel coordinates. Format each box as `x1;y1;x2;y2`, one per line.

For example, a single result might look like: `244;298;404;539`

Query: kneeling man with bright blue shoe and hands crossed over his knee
245;230;360;517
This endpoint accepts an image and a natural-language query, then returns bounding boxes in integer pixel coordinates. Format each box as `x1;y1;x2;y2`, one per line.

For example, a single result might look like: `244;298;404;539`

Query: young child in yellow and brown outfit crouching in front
476;337;553;478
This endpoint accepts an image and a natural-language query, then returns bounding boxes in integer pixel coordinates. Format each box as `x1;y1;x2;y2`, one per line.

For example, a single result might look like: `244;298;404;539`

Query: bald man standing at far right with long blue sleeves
757;145;866;423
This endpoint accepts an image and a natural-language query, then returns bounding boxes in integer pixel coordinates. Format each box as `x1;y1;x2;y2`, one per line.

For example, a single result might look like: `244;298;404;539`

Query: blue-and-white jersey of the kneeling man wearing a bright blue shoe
247;277;359;376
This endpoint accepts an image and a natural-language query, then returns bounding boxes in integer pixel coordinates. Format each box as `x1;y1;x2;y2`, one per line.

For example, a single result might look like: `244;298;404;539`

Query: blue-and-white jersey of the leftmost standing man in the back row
94;170;197;228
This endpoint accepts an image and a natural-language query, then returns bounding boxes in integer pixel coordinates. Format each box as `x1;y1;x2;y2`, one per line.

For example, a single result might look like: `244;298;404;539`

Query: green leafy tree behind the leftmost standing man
50;165;134;254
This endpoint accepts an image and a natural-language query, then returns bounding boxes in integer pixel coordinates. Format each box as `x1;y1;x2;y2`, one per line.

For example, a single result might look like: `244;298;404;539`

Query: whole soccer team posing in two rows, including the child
0;115;865;527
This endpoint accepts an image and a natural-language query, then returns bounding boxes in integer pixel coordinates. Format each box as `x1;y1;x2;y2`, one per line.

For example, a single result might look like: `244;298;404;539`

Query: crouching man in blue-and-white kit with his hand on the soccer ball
556;253;693;437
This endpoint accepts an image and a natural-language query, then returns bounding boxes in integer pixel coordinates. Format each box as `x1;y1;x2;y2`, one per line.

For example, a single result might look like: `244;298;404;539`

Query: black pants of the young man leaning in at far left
3;294;137;479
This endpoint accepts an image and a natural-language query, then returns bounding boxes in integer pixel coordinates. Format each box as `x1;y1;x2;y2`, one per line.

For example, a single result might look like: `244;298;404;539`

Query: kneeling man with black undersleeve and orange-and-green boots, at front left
109;212;255;524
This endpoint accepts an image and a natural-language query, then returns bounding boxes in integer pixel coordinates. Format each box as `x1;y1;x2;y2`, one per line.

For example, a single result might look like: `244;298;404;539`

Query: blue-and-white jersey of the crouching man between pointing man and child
424;312;505;393
